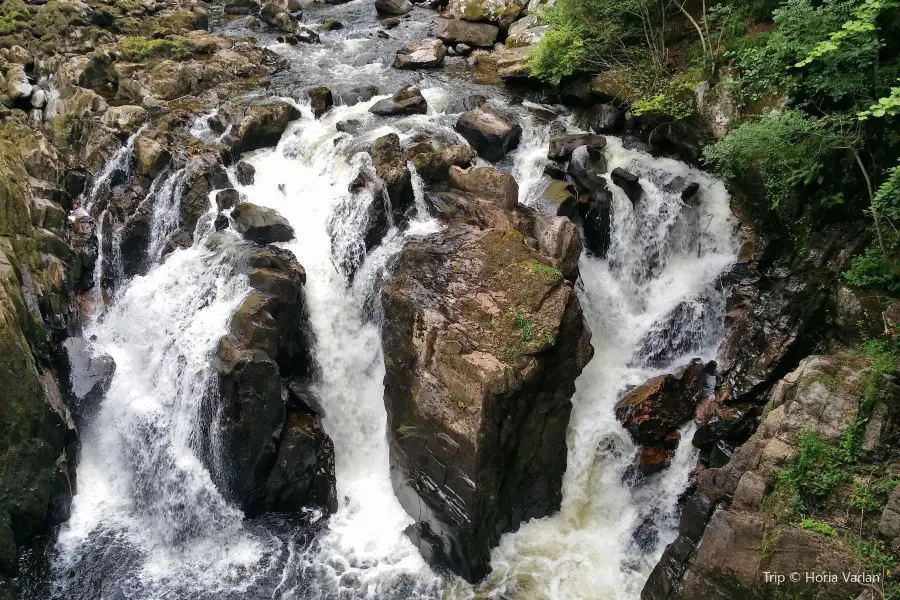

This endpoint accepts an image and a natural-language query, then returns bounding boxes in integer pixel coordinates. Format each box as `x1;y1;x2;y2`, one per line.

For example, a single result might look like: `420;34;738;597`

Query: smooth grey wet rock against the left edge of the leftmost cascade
60;337;116;422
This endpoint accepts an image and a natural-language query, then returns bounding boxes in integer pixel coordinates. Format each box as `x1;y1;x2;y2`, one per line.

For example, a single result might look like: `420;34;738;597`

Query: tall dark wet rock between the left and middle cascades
215;246;337;515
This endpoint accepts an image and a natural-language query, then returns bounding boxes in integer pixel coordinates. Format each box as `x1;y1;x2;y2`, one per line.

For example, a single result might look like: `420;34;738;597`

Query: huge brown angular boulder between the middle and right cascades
382;220;593;582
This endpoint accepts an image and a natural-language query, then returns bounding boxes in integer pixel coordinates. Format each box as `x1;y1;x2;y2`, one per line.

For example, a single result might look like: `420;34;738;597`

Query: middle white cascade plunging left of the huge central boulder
229;96;439;600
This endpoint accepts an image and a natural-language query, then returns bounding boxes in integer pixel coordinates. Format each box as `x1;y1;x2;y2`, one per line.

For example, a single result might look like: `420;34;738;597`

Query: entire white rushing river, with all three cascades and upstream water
24;0;737;600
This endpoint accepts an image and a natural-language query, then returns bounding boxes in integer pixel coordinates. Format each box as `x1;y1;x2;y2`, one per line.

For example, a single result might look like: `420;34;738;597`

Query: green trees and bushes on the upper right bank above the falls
529;0;900;291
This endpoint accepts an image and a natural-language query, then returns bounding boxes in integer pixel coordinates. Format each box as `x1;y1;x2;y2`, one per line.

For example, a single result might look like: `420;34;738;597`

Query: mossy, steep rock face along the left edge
0;133;78;598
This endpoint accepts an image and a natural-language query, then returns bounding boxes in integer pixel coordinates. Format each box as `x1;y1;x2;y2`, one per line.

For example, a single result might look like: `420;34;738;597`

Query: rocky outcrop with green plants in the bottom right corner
641;354;900;600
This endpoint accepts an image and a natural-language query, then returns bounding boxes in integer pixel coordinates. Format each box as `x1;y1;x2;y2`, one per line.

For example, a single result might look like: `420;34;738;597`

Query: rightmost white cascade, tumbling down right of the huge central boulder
450;136;738;600
